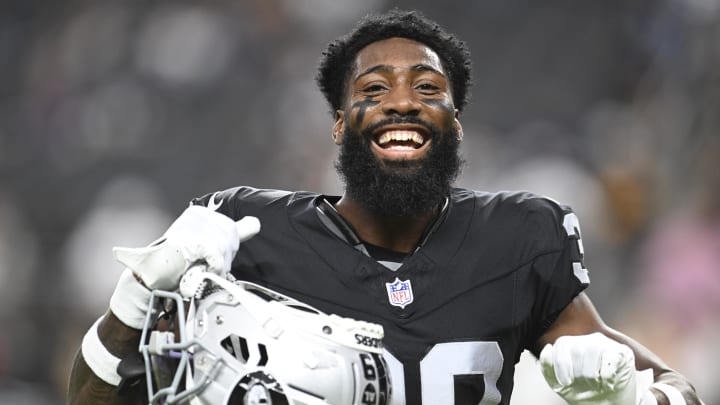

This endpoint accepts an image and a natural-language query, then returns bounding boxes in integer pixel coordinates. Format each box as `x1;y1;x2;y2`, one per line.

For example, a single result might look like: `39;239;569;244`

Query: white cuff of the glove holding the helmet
110;269;151;329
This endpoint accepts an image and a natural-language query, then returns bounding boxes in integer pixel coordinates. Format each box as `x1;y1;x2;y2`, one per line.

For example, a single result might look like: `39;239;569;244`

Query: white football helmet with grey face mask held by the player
140;268;391;405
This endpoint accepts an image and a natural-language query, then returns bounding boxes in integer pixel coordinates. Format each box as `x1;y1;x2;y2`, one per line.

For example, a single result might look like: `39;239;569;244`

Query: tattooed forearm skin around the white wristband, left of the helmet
68;311;147;405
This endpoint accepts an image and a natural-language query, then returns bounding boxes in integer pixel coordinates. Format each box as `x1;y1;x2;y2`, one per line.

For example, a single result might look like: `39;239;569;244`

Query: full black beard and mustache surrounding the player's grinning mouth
335;117;463;217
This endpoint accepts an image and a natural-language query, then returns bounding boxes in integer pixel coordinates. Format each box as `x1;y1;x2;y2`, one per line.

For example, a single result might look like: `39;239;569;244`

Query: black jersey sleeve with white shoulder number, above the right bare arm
528;199;590;348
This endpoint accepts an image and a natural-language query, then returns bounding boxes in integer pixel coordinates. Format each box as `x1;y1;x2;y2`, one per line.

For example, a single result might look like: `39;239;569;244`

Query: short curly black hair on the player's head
315;9;471;114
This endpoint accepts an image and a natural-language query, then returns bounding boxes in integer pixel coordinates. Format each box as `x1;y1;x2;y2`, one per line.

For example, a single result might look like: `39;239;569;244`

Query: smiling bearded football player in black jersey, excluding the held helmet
70;10;701;405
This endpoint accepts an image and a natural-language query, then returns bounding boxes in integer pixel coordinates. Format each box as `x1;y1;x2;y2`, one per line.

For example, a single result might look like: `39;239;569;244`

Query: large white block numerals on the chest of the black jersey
383;342;504;405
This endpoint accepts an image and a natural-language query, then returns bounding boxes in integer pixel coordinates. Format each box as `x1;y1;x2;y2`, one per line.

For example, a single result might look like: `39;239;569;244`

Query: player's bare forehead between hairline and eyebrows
354;38;445;77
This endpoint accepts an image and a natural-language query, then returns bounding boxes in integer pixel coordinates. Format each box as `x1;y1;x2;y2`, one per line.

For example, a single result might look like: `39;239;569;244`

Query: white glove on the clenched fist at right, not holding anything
540;333;653;405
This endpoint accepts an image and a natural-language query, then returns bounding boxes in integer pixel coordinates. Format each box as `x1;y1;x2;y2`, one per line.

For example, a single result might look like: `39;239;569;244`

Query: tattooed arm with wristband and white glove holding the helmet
68;206;259;405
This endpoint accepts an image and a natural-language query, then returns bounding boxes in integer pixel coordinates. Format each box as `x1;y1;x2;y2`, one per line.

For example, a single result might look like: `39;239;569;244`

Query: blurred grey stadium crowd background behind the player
0;0;720;405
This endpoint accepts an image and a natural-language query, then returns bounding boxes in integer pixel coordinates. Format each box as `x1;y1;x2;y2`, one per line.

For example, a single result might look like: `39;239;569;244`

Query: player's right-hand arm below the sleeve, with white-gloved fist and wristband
533;293;702;405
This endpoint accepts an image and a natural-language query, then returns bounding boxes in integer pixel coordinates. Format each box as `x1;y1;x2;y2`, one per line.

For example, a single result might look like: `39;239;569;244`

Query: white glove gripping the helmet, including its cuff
110;206;260;329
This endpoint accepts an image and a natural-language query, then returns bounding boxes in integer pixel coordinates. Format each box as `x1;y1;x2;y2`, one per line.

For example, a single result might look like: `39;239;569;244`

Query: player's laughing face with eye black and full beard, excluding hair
333;38;462;227
